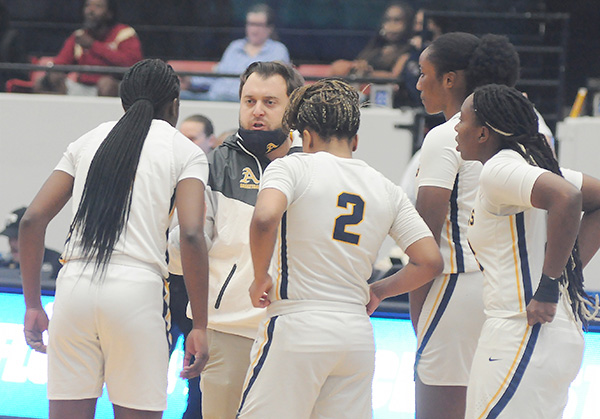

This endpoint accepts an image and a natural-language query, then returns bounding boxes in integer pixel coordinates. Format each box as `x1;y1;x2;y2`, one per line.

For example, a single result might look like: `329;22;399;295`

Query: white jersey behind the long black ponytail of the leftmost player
55;119;208;278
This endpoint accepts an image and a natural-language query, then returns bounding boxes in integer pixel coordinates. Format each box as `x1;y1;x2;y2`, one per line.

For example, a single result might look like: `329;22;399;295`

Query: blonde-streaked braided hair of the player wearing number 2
283;79;360;142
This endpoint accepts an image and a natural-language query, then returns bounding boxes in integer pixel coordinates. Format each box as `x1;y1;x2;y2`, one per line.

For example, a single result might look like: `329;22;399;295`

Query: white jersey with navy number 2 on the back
260;152;431;306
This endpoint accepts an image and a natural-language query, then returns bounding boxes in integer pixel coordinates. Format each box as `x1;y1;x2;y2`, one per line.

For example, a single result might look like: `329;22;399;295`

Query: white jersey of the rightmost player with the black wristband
468;150;583;317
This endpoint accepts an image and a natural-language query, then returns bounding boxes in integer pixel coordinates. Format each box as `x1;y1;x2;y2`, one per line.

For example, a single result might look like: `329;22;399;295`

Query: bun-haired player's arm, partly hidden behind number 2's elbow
409;186;452;331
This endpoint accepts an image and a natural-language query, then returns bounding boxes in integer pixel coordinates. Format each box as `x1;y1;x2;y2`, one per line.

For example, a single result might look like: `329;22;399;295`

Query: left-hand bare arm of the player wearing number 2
249;188;287;307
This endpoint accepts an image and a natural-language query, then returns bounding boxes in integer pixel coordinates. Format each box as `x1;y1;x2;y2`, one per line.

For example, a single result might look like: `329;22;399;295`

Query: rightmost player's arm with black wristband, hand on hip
527;172;582;325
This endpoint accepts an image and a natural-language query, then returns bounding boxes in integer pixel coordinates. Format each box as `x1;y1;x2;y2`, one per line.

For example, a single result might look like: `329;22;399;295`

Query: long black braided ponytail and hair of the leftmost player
67;59;179;271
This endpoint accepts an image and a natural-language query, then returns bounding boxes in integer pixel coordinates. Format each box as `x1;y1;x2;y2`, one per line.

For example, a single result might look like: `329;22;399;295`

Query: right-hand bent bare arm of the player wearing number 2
367;237;444;315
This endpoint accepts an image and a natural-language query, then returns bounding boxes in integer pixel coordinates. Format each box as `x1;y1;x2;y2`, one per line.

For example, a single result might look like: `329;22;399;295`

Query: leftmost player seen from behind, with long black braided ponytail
19;60;208;419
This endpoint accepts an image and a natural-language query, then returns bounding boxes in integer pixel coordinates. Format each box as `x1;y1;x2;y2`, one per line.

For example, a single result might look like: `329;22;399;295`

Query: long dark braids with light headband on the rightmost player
473;84;598;327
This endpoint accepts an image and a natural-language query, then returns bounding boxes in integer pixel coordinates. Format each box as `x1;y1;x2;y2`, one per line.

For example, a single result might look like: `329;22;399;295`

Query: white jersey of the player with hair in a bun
417;113;481;274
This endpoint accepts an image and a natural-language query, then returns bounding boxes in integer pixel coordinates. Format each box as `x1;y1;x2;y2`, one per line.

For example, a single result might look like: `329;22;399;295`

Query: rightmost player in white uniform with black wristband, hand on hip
455;85;600;419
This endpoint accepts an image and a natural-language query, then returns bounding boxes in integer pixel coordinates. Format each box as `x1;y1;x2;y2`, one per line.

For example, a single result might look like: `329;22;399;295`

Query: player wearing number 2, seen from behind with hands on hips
240;80;443;418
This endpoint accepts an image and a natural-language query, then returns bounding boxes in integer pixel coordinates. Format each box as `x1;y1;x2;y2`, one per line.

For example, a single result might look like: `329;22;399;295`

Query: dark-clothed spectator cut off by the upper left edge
0;0;28;92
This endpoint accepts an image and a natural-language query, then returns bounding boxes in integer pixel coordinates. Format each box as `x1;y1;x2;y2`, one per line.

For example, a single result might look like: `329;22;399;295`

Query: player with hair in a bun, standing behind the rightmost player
410;32;519;419
